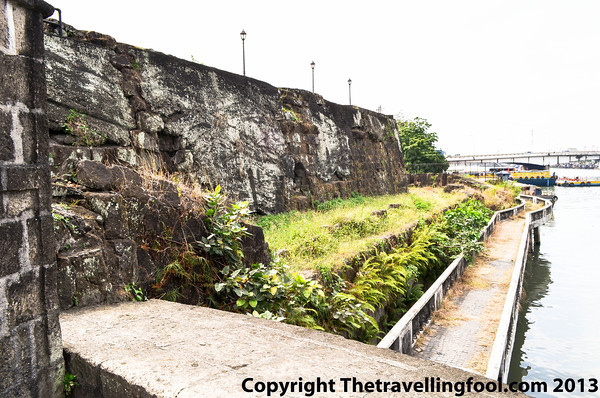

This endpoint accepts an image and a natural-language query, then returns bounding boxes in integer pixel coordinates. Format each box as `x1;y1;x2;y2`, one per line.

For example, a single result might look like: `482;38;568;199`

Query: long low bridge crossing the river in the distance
446;151;600;168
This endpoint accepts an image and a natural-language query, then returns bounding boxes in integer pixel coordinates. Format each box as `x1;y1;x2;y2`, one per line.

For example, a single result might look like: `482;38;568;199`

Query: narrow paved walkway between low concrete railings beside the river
415;215;525;374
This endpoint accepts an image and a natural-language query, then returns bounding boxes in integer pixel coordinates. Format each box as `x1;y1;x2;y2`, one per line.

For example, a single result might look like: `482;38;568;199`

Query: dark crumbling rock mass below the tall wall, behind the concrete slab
52;160;270;310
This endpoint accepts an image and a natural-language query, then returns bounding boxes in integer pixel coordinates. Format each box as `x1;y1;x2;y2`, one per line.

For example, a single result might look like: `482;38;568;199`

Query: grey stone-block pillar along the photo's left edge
0;0;64;398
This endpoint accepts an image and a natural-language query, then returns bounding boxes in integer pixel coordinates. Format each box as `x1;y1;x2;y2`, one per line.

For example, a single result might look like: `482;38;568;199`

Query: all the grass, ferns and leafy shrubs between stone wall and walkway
139;176;506;342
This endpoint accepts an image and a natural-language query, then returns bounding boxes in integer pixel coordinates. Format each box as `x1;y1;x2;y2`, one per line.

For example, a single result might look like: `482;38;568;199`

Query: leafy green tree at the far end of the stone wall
398;117;449;173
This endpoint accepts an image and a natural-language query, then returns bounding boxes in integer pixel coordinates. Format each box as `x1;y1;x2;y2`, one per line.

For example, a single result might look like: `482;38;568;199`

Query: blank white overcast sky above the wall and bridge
47;0;600;155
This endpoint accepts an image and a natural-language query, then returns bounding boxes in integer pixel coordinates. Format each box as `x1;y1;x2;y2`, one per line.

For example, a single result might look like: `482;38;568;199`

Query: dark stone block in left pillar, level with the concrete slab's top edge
6;270;45;327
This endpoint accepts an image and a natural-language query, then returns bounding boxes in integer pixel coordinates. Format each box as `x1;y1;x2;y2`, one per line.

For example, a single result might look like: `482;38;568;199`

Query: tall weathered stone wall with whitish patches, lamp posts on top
45;25;407;214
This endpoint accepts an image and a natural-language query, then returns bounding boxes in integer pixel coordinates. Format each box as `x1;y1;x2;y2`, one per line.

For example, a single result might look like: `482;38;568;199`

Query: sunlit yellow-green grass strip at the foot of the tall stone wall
255;187;466;272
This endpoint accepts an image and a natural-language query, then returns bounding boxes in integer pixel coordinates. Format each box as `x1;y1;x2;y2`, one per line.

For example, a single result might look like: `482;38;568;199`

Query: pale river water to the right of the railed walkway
509;169;600;397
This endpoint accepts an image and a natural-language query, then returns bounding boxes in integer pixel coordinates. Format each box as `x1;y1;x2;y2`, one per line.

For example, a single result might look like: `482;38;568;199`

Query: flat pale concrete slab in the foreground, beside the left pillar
61;300;520;398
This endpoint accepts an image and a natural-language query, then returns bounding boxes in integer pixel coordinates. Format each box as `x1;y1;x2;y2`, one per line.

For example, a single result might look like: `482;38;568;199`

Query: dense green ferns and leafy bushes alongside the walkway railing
215;195;491;342
